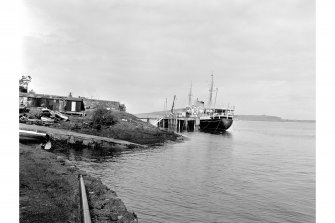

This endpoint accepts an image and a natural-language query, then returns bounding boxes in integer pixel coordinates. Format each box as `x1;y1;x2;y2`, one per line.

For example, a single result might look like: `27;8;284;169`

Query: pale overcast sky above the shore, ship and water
23;0;315;119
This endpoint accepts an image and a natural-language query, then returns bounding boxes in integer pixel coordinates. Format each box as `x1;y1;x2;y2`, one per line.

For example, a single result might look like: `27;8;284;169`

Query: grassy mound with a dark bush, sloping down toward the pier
51;109;180;145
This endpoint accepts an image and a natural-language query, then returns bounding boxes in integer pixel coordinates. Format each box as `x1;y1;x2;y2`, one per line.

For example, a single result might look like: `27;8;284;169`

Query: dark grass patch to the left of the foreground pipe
20;145;79;222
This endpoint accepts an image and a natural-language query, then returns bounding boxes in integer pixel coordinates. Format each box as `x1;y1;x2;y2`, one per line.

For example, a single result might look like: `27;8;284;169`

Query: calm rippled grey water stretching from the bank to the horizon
70;121;315;223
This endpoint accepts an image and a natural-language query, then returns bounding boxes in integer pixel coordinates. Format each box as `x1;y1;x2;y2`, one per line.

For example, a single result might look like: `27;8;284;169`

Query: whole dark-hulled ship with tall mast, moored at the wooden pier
198;74;235;132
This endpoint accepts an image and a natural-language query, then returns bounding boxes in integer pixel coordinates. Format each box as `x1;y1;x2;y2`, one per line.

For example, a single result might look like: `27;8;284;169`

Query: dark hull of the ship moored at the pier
200;118;233;132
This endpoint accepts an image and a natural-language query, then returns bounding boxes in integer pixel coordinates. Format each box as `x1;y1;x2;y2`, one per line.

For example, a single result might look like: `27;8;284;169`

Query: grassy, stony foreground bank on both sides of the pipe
20;144;137;223
